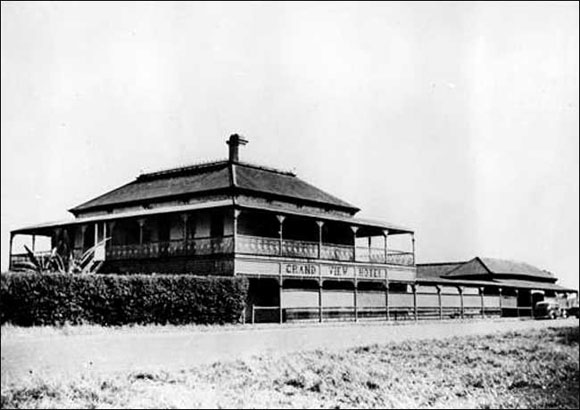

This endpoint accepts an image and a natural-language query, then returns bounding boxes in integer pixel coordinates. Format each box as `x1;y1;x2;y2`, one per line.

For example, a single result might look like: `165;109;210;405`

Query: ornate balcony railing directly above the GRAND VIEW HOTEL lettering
236;235;414;266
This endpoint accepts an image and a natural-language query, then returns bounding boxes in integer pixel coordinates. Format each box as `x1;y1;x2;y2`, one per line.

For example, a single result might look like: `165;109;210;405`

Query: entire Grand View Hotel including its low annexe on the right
10;134;575;321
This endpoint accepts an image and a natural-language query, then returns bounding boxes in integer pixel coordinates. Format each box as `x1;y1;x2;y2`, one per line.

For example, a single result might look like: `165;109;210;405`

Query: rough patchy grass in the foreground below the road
1;326;580;408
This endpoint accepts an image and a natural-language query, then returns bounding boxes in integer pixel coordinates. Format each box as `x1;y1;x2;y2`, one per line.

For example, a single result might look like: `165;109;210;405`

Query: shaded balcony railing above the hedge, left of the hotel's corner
107;236;234;260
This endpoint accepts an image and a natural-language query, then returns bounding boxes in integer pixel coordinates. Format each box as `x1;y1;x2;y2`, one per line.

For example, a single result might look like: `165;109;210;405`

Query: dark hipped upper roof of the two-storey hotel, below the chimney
70;161;359;215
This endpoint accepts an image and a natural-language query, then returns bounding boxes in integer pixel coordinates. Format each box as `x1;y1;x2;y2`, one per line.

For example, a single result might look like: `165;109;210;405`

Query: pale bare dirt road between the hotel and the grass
1;318;578;385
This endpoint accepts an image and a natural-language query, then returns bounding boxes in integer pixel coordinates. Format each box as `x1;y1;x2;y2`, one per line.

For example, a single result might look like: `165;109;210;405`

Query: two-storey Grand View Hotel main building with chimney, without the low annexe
10;134;416;317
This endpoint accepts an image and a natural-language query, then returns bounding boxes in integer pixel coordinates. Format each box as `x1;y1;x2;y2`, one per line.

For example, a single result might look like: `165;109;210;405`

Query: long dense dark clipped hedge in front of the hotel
0;272;248;326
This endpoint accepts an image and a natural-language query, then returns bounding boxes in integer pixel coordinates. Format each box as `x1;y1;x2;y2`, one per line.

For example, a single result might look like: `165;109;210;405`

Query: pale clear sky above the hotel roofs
0;2;579;289
